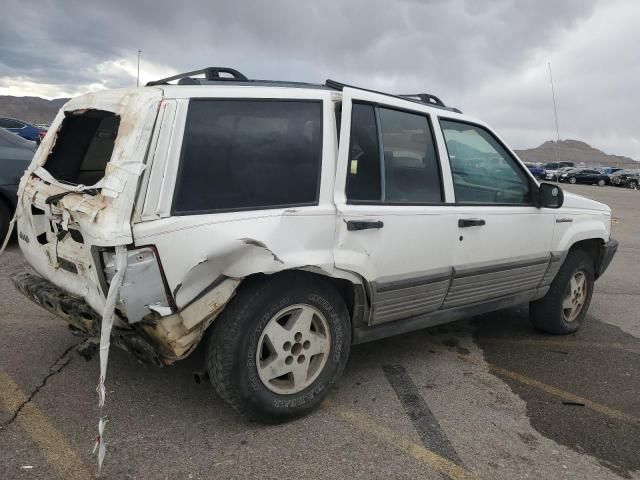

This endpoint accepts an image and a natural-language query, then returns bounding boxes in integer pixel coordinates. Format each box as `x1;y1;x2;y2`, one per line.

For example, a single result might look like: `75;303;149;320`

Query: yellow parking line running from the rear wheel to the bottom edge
327;402;474;480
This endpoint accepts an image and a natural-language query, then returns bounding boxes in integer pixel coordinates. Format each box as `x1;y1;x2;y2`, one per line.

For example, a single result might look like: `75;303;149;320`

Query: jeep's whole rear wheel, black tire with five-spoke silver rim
207;272;351;423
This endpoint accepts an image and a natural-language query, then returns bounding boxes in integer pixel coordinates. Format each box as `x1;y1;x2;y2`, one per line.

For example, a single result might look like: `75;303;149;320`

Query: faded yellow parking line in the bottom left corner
0;370;93;480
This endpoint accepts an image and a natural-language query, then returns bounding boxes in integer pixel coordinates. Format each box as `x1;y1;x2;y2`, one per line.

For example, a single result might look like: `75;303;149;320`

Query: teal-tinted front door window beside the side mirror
440;119;531;205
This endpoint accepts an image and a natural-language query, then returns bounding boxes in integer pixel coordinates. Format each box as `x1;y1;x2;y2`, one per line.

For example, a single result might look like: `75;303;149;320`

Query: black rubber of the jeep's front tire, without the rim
529;249;595;335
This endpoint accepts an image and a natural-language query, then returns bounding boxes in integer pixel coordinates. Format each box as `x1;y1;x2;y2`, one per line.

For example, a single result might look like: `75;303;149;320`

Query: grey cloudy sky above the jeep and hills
0;0;640;160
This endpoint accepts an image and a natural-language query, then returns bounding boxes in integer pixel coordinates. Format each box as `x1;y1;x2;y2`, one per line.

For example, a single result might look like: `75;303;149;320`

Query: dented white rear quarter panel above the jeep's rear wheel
133;209;335;308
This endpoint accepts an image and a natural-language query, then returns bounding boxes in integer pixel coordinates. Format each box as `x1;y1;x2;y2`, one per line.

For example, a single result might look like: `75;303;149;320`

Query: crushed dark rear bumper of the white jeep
11;273;165;366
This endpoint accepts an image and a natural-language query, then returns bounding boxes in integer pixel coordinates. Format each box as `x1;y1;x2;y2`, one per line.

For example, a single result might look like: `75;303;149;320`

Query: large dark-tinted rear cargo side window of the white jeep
173;99;322;215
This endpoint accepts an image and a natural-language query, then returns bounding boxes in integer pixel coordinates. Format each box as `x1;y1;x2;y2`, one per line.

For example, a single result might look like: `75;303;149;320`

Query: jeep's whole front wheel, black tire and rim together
529;250;595;335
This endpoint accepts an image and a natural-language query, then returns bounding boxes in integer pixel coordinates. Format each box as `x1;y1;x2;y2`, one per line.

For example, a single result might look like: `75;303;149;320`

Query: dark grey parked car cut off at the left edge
0;128;36;240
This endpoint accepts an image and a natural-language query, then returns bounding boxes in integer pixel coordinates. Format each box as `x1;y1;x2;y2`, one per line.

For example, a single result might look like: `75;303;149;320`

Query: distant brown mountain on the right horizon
515;140;640;168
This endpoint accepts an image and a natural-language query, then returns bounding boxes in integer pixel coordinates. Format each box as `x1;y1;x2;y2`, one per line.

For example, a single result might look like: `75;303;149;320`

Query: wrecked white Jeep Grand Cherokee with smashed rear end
14;68;617;421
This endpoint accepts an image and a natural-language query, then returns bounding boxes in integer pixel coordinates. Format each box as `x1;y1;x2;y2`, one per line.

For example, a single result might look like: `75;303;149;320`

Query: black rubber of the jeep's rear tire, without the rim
207;272;351;423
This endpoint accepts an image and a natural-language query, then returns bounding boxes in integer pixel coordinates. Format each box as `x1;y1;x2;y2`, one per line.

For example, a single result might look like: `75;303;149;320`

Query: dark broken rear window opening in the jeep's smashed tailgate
45;110;120;185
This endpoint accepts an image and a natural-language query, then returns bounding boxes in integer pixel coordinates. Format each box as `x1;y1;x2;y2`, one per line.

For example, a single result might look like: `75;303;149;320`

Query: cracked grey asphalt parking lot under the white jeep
0;186;640;479
